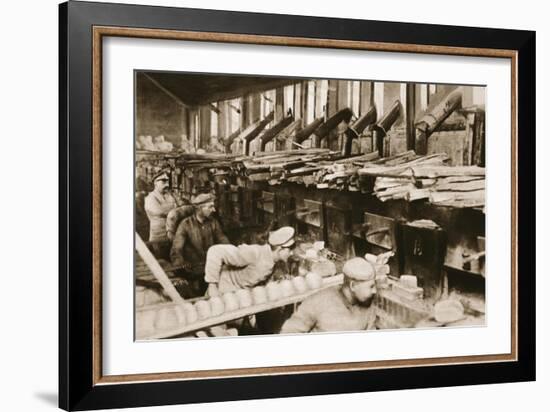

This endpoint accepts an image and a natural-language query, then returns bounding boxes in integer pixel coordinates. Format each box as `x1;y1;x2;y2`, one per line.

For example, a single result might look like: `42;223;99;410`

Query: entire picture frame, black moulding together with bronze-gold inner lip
59;1;535;410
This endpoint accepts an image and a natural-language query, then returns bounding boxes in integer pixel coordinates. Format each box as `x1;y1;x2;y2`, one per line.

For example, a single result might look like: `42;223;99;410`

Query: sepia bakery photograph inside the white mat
134;70;486;341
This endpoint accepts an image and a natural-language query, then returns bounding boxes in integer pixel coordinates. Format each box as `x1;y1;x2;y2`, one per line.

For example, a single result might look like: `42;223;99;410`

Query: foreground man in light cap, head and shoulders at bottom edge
281;257;378;333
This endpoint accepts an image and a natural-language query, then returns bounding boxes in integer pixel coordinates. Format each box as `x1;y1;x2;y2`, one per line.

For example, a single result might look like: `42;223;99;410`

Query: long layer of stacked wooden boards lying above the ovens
137;148;485;208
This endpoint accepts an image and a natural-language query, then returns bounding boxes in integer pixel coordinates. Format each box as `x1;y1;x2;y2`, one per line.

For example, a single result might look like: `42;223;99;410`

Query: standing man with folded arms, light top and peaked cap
144;170;176;258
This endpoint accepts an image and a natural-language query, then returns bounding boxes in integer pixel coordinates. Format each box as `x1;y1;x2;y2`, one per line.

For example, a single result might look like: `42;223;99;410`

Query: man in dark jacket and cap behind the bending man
170;193;229;295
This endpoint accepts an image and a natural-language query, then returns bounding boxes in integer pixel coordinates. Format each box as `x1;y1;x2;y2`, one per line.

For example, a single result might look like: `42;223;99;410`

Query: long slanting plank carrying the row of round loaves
138;274;344;340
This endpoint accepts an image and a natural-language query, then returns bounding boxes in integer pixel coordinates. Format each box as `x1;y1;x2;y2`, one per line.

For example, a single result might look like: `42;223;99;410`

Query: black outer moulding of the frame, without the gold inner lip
59;1;536;410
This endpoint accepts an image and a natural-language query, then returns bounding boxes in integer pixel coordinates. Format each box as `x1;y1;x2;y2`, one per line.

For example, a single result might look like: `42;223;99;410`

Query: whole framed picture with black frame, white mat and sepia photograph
58;1;538;410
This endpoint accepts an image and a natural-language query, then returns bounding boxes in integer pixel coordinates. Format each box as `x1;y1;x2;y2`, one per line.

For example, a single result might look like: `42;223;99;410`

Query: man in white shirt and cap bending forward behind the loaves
204;226;294;296
